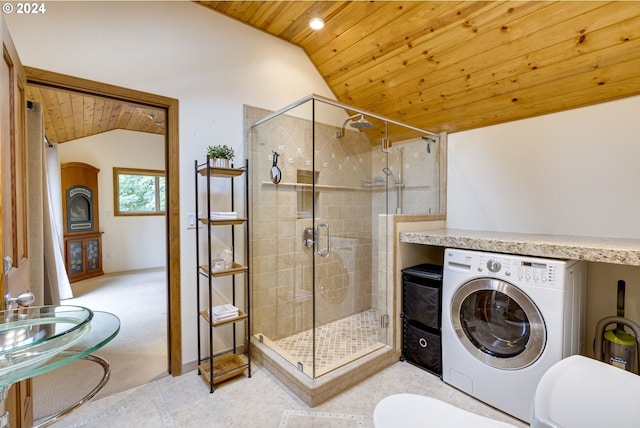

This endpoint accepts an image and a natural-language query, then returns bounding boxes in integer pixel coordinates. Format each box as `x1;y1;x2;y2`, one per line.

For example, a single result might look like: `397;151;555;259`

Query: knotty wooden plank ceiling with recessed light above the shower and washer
198;1;640;132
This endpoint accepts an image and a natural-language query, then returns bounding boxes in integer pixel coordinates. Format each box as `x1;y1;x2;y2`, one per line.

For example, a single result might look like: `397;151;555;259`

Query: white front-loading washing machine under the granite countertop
442;249;586;423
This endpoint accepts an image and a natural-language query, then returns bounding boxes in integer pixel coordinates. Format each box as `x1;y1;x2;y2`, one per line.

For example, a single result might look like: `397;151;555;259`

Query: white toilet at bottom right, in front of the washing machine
373;355;640;428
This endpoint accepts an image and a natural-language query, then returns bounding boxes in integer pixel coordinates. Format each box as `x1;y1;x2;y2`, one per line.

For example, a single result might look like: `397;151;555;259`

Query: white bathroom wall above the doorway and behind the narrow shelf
5;1;335;363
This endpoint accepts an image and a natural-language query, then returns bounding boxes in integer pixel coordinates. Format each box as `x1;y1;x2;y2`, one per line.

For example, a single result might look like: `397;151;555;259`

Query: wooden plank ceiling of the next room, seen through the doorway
27;85;166;143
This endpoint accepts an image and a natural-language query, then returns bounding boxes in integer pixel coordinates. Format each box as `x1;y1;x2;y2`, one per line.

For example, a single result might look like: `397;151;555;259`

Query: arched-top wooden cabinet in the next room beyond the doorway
60;162;103;282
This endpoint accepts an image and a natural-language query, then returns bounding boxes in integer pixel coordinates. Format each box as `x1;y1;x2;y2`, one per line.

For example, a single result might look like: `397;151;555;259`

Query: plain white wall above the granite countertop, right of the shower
447;97;640;238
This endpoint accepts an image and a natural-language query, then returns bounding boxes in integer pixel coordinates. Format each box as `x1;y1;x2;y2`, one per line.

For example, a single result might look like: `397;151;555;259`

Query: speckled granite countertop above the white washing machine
400;229;640;266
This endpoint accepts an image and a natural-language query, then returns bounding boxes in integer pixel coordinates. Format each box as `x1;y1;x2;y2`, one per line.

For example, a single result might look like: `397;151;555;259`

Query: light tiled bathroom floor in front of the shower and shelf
52;362;528;428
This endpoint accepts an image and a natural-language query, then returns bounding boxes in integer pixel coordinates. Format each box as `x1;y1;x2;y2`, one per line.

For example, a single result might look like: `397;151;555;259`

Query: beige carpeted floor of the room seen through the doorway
33;269;167;421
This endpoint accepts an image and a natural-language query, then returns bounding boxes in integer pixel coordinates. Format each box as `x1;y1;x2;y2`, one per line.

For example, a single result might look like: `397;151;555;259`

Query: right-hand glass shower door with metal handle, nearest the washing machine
312;100;388;377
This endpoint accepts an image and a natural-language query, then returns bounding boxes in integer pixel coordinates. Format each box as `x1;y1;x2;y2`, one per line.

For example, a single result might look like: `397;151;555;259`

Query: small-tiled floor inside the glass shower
265;310;384;376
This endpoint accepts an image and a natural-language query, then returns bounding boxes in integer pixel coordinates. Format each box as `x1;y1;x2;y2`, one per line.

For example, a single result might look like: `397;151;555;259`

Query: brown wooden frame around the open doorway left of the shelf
24;66;182;376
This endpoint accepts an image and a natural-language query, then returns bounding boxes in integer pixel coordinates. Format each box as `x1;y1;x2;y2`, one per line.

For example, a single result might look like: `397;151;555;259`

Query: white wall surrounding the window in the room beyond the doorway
58;130;166;273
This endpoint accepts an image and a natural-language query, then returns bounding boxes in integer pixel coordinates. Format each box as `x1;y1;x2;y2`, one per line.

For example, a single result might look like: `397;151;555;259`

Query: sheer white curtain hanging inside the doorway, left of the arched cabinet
44;144;73;299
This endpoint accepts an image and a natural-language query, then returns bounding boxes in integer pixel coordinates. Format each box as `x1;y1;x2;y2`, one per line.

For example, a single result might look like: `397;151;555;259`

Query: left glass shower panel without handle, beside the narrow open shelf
250;101;315;377
